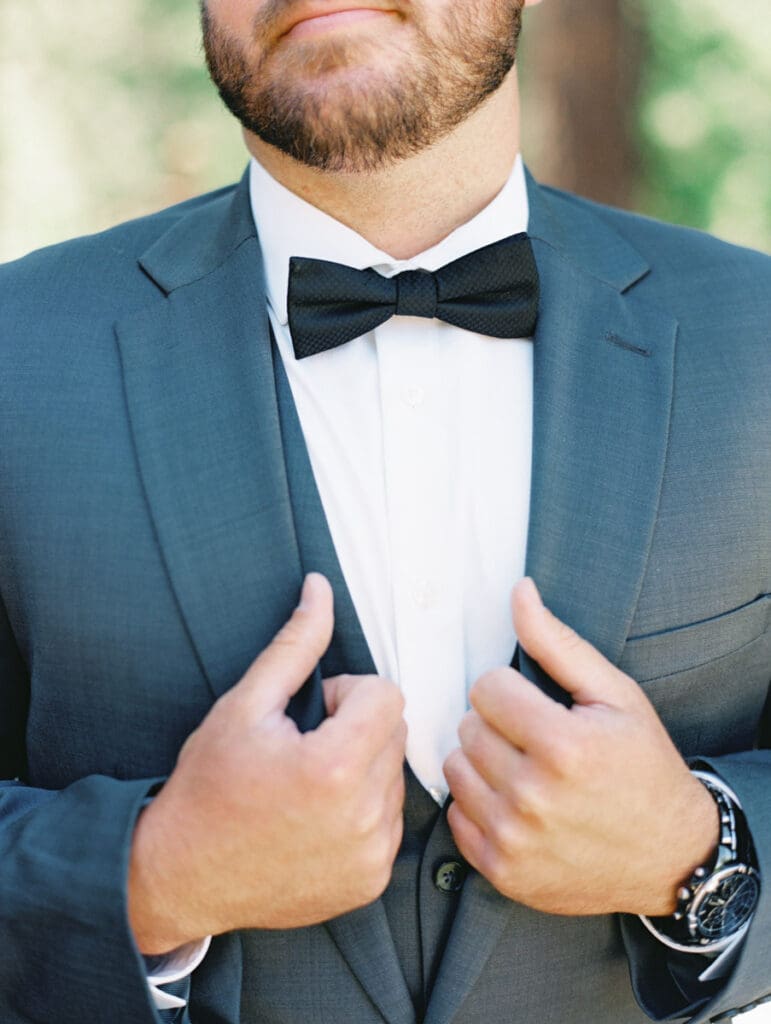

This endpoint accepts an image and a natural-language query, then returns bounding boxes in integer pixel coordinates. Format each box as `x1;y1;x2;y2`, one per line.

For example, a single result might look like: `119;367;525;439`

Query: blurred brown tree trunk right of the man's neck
520;0;642;207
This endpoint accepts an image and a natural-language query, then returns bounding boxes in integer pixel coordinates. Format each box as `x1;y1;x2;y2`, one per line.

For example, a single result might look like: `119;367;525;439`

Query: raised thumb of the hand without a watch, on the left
235;572;335;718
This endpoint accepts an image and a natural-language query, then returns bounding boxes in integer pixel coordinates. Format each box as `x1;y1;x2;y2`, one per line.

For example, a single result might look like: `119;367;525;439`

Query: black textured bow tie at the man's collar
288;233;539;359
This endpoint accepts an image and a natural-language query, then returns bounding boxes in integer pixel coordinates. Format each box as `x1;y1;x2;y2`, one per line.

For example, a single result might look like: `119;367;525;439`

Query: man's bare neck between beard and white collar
245;72;519;259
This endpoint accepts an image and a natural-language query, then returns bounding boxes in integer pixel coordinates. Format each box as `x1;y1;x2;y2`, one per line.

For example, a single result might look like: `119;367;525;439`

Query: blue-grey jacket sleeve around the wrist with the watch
622;737;771;1024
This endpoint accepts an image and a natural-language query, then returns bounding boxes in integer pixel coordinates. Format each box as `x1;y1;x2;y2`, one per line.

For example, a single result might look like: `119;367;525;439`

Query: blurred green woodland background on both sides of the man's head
0;0;771;260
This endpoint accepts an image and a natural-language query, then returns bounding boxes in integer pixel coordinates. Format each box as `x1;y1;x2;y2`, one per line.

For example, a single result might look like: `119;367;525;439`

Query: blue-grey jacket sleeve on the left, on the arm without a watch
0;589;169;1024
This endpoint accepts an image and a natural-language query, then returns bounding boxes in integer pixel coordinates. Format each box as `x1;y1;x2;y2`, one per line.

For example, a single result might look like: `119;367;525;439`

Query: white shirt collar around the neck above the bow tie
250;156;529;325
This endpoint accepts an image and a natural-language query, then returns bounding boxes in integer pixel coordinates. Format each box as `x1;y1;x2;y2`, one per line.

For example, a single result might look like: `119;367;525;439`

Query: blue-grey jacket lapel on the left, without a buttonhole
116;172;323;728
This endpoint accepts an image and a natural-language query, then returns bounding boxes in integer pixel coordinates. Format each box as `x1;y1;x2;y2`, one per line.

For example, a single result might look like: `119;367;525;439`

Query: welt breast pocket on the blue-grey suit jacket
618;594;771;683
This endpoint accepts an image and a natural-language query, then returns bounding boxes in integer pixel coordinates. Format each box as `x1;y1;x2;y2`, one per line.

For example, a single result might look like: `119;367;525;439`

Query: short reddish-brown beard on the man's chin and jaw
202;0;522;174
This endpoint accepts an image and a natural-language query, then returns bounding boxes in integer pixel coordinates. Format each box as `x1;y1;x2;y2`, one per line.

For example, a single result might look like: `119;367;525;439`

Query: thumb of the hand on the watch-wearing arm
511;578;638;707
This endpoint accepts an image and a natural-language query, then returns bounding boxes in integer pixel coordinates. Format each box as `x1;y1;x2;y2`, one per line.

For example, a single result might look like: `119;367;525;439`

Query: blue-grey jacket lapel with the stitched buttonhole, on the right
426;180;677;1024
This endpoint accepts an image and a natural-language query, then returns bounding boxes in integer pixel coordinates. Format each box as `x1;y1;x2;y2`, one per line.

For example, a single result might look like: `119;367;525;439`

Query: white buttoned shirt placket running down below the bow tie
376;317;466;800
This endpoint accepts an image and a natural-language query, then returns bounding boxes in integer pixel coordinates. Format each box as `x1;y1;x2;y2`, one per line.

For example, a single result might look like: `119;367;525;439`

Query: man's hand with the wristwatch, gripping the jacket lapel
444;580;719;916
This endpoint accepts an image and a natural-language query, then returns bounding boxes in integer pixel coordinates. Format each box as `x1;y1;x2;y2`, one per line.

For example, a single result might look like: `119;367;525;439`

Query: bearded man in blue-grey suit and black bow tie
0;0;771;1024
